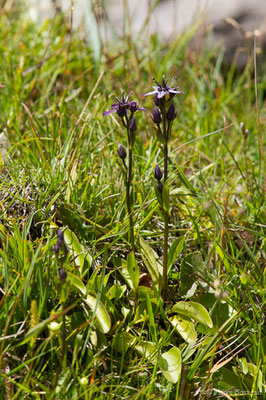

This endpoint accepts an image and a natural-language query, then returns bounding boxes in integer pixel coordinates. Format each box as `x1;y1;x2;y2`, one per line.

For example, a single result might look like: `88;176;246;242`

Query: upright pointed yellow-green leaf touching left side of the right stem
139;236;163;292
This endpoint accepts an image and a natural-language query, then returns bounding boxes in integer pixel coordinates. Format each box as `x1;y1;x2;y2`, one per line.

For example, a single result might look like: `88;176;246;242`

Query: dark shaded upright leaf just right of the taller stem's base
179;251;204;296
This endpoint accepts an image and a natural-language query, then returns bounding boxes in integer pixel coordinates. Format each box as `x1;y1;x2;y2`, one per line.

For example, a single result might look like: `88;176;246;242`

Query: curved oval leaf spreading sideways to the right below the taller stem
171;301;213;328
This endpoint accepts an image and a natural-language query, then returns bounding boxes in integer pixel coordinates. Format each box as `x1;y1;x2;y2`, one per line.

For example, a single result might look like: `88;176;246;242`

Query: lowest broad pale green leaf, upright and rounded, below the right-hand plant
159;347;181;383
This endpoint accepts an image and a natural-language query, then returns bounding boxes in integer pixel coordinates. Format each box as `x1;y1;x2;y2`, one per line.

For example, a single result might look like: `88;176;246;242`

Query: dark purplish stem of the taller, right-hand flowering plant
162;142;169;300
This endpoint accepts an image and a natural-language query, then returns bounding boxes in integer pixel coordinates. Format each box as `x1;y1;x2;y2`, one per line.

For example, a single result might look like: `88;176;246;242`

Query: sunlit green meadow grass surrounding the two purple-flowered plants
0;3;266;400
